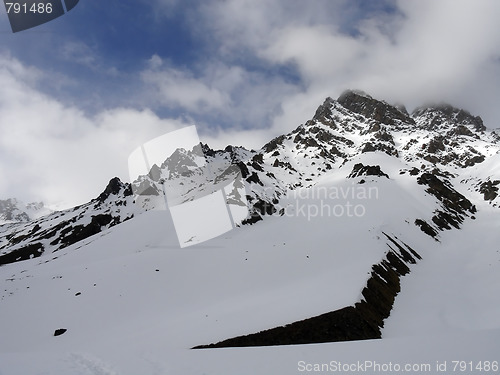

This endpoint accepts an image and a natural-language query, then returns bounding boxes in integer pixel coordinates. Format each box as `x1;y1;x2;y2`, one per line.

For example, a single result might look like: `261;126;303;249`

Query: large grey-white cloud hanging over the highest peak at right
192;0;500;129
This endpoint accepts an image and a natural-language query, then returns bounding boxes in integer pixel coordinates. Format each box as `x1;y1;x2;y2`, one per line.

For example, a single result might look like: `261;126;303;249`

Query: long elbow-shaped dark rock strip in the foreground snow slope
193;233;421;349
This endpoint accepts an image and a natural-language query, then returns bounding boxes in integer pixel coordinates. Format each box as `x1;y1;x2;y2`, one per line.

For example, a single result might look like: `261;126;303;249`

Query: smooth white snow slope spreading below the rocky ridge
0;154;500;374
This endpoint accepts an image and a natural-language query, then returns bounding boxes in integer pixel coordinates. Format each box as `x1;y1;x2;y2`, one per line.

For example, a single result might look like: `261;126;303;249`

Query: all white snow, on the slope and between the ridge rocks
0;98;500;375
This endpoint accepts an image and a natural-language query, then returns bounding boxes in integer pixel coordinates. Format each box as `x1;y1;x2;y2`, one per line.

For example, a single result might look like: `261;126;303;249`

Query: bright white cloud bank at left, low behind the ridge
0;56;187;206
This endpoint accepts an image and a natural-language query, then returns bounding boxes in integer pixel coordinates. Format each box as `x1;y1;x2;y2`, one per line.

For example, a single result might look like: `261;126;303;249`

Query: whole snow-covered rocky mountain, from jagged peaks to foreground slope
0;91;500;374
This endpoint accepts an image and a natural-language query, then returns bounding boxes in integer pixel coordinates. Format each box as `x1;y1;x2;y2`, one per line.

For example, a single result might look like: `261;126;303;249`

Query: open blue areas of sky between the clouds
2;0;402;127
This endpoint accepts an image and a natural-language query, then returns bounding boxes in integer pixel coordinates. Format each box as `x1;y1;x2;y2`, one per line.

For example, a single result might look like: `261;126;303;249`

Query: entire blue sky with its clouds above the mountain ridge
0;0;500;205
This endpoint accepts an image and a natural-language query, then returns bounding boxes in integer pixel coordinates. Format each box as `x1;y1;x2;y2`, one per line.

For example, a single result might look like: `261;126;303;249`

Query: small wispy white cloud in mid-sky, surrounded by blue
141;55;297;129
